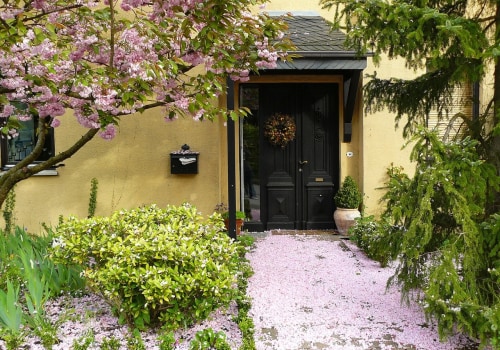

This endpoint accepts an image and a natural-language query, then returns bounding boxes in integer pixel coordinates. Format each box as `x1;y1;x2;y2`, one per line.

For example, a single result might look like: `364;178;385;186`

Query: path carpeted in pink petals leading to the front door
248;234;476;350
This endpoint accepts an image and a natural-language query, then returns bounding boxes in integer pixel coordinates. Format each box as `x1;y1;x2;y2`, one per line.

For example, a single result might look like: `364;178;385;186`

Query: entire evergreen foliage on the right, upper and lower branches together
320;0;500;348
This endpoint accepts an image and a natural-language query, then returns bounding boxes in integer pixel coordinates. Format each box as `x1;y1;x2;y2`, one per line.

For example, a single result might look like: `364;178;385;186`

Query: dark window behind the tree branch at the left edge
1;108;54;170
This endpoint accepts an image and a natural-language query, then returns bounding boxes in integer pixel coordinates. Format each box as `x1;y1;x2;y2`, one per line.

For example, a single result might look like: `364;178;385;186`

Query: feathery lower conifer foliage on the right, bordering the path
362;130;500;345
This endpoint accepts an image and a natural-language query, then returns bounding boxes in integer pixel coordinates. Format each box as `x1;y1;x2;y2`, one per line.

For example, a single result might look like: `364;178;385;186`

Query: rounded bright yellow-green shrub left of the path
52;204;238;329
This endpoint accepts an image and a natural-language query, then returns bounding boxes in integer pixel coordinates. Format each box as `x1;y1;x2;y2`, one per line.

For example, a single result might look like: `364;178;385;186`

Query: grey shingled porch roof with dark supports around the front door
227;12;369;234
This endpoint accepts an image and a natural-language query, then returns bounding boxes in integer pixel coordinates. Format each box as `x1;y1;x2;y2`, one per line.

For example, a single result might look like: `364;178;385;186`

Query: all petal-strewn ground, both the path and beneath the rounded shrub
0;234;477;350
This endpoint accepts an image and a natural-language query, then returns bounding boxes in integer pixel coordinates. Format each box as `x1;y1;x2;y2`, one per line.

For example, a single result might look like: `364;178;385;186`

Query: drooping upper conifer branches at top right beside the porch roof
320;0;497;135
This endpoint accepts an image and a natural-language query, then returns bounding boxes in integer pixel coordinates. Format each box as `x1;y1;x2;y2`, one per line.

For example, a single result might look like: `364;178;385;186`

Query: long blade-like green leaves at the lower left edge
0;227;85;349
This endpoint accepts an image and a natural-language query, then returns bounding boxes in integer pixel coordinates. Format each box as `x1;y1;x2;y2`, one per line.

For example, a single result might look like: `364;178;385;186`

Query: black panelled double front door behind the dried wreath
258;83;339;229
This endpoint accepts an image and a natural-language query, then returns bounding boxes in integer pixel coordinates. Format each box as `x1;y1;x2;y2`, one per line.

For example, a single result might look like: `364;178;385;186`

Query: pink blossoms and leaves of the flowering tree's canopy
0;0;290;144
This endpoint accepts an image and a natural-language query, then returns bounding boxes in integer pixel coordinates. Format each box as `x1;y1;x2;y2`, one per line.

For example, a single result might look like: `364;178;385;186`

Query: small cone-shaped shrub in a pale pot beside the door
333;175;363;235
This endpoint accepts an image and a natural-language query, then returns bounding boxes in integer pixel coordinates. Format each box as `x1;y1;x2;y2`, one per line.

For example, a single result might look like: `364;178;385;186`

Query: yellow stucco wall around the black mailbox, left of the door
11;110;226;231
